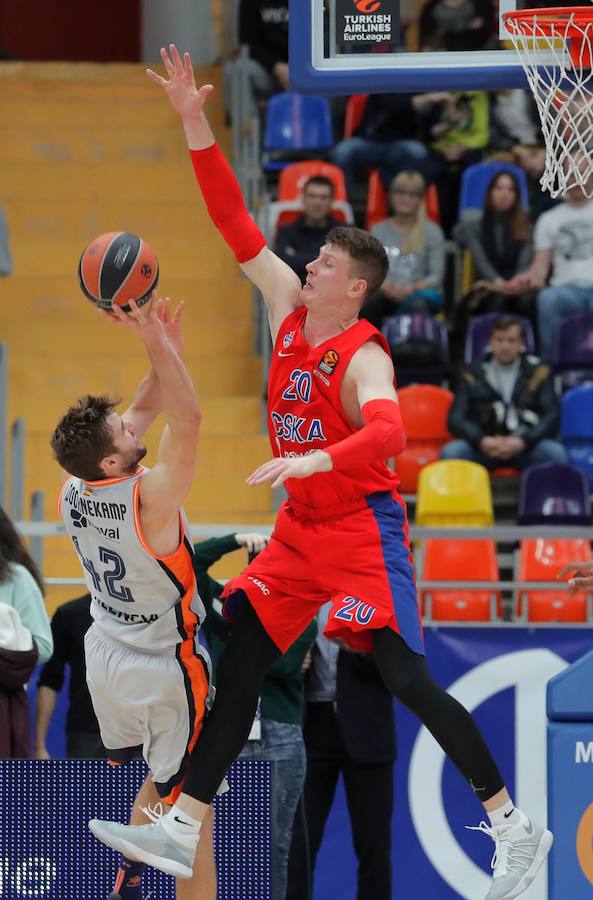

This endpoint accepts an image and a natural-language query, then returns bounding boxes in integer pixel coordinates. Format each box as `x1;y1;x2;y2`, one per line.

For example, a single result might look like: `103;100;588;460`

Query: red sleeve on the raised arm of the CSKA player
190;144;266;263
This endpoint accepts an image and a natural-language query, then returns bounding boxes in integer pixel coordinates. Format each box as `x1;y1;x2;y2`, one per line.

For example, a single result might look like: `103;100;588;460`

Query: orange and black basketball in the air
78;231;159;312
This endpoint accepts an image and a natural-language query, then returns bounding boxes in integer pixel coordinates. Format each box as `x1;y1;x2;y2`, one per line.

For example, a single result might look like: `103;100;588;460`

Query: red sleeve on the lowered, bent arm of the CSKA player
326;400;406;469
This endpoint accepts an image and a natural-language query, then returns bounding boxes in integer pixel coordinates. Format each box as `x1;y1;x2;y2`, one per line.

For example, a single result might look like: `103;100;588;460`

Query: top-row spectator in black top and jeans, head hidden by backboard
332;94;428;191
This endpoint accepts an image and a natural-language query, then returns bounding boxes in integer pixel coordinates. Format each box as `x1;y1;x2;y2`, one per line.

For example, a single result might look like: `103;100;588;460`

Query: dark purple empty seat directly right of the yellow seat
517;463;592;525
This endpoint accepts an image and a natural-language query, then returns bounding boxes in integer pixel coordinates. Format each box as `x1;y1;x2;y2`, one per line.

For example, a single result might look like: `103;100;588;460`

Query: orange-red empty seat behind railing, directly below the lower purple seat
516;538;591;622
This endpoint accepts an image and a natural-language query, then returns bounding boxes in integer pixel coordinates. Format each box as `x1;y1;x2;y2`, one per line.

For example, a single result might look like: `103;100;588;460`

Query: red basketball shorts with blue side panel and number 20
223;492;424;654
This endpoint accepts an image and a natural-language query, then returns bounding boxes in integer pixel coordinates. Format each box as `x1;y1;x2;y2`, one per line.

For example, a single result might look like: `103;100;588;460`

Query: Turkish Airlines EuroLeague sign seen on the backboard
335;0;399;53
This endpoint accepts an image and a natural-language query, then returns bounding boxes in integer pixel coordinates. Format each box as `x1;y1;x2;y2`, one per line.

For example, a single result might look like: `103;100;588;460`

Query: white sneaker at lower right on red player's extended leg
467;813;554;900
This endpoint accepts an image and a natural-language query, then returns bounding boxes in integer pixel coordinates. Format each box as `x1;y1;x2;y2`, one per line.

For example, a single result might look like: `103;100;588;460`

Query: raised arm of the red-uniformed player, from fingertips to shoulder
147;44;301;339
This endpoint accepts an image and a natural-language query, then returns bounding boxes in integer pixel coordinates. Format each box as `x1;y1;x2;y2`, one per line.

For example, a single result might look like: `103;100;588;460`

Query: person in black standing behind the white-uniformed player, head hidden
33;594;107;759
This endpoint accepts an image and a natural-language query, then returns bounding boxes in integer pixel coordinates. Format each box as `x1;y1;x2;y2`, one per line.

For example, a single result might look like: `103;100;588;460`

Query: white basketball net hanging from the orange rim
504;9;593;197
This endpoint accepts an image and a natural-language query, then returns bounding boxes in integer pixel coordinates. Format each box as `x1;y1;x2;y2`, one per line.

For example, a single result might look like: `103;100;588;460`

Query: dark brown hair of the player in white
50;394;119;481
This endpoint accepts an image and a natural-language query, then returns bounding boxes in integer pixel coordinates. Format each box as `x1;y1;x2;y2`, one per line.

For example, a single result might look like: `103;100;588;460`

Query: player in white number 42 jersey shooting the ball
51;295;216;900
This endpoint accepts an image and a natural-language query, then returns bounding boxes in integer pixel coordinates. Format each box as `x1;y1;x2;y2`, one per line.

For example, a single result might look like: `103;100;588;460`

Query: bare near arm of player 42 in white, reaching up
114;302;201;540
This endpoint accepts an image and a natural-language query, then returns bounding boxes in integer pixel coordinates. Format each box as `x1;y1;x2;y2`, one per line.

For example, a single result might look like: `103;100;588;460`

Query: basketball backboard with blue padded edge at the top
289;0;582;94
